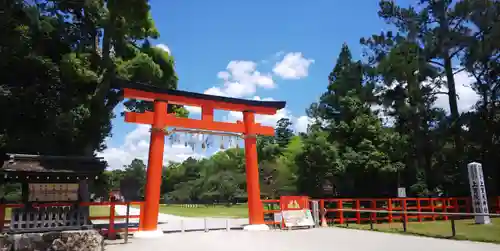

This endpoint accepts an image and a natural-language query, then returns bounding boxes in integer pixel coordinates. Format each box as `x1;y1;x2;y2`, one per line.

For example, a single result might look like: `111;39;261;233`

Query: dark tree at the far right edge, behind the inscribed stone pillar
455;0;500;194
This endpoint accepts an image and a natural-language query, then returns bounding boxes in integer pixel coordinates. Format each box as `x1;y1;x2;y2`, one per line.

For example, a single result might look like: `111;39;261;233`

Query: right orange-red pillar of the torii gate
243;111;264;225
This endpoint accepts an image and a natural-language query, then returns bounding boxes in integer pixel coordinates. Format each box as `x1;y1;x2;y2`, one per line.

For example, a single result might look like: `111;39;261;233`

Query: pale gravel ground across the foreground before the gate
105;227;500;251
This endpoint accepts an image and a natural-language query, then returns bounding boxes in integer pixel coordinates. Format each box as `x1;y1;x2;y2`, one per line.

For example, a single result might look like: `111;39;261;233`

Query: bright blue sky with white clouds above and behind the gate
102;0;434;171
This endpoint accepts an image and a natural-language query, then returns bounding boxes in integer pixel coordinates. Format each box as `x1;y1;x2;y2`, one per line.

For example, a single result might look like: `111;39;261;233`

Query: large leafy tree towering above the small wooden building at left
0;0;186;155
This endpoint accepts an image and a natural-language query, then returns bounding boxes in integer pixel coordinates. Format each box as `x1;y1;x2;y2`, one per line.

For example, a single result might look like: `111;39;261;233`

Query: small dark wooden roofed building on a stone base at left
0;154;106;233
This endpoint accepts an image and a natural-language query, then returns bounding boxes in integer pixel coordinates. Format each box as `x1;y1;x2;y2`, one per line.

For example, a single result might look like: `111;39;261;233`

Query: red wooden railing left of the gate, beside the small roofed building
0;201;144;239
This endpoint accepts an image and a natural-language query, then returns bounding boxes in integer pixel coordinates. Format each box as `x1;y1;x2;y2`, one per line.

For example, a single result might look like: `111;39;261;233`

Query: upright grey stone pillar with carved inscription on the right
467;162;491;224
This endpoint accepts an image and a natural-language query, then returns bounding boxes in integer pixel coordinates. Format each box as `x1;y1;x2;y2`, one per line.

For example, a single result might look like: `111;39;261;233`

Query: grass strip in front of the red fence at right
336;218;500;243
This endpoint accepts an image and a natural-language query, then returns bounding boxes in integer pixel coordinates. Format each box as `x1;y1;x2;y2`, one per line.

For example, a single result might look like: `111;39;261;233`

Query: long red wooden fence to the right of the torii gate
263;196;500;225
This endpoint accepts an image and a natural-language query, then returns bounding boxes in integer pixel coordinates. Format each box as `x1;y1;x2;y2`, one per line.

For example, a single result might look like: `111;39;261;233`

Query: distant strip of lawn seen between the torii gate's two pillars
160;204;248;218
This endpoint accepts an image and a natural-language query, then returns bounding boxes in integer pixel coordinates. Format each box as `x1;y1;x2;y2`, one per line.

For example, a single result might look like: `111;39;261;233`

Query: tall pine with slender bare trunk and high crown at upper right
378;0;471;192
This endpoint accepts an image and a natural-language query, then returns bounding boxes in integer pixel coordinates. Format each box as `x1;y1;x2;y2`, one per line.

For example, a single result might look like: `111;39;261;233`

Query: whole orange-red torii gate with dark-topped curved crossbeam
123;84;286;237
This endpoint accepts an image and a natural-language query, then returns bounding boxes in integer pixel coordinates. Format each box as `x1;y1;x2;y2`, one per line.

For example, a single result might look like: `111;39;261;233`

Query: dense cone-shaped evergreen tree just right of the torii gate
302;44;401;196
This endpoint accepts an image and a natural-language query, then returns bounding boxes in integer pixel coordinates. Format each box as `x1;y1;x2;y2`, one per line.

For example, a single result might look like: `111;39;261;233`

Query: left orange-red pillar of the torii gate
142;100;167;231
